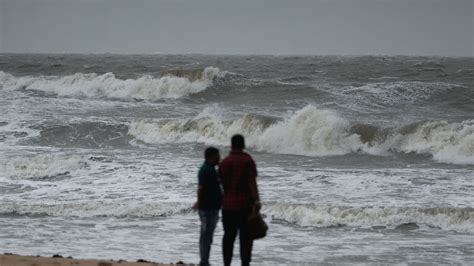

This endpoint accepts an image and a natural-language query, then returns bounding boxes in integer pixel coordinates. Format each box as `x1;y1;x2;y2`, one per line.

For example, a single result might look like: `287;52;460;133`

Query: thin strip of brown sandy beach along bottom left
0;254;192;266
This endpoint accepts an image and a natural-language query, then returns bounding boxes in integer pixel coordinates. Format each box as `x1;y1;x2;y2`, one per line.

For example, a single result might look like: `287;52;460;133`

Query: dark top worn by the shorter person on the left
198;162;222;210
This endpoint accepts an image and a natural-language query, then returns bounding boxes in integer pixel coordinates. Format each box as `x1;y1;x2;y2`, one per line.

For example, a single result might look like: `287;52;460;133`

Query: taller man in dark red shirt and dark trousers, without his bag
219;135;260;265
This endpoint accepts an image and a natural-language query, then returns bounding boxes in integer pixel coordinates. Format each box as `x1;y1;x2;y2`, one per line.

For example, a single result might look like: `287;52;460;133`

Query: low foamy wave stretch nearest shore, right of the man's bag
263;204;474;234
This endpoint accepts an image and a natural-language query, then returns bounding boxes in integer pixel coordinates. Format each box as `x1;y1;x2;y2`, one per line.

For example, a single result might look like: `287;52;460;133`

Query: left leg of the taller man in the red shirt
222;210;239;266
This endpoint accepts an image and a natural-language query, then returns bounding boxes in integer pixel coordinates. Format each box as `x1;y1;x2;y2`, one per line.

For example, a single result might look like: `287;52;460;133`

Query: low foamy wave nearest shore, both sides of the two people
0;200;474;234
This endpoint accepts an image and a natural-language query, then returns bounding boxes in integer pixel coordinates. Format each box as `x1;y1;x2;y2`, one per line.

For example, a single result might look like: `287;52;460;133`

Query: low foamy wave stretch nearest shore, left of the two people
0;201;191;217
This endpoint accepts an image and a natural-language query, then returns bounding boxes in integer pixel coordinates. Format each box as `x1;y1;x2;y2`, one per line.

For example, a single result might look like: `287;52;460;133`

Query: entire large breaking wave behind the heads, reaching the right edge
128;105;474;164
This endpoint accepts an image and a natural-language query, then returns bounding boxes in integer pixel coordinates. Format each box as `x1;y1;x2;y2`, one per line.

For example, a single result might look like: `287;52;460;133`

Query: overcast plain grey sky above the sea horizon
0;0;474;56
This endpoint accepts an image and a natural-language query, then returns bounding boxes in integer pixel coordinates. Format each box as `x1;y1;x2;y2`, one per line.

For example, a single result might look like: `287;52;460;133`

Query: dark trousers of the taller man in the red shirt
222;209;253;265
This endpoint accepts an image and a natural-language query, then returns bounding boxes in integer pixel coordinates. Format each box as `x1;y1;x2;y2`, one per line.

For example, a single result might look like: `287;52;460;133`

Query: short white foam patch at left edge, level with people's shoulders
0;154;87;179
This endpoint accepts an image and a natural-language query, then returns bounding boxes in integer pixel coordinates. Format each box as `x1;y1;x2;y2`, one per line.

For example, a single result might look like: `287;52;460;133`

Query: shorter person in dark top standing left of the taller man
193;147;222;265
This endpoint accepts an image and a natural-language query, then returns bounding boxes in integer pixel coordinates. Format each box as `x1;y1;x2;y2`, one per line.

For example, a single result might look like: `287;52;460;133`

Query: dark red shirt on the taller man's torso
219;151;257;210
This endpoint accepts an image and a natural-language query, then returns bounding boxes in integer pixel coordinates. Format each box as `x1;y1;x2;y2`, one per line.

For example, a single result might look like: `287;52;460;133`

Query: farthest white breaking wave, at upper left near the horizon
0;67;222;101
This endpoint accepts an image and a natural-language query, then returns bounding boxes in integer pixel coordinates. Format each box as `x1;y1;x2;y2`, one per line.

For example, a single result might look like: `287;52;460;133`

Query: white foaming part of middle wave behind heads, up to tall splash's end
129;106;363;156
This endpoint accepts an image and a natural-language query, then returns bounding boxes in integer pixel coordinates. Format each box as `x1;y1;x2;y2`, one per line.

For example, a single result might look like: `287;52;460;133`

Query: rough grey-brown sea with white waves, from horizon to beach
0;54;474;265
